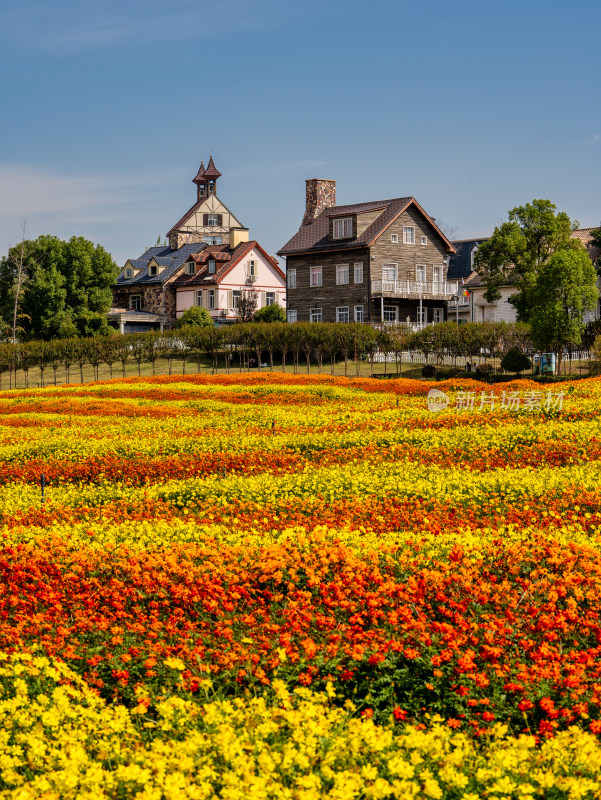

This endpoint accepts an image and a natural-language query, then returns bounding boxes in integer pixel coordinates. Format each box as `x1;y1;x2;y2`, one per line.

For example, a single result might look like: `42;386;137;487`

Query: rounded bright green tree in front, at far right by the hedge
530;248;599;372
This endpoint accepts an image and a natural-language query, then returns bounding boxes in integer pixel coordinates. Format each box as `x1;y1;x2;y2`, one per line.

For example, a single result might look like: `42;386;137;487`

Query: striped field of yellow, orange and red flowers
0;373;601;800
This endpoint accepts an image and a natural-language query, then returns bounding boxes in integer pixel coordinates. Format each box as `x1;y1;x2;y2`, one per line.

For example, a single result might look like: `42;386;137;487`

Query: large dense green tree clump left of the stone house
0;236;119;339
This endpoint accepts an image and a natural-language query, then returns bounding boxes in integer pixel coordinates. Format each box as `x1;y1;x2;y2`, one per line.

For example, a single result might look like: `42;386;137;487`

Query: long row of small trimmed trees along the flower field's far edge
0;322;556;385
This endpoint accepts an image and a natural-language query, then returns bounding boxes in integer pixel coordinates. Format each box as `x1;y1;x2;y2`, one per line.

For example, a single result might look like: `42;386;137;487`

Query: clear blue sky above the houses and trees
0;0;601;264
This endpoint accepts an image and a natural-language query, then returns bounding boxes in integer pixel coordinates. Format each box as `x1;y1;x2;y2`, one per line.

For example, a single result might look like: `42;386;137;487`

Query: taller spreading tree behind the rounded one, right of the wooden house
474;200;584;322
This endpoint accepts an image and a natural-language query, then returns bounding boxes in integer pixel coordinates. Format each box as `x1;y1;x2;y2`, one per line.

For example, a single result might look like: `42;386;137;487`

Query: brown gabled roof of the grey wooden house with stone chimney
278;197;454;256
